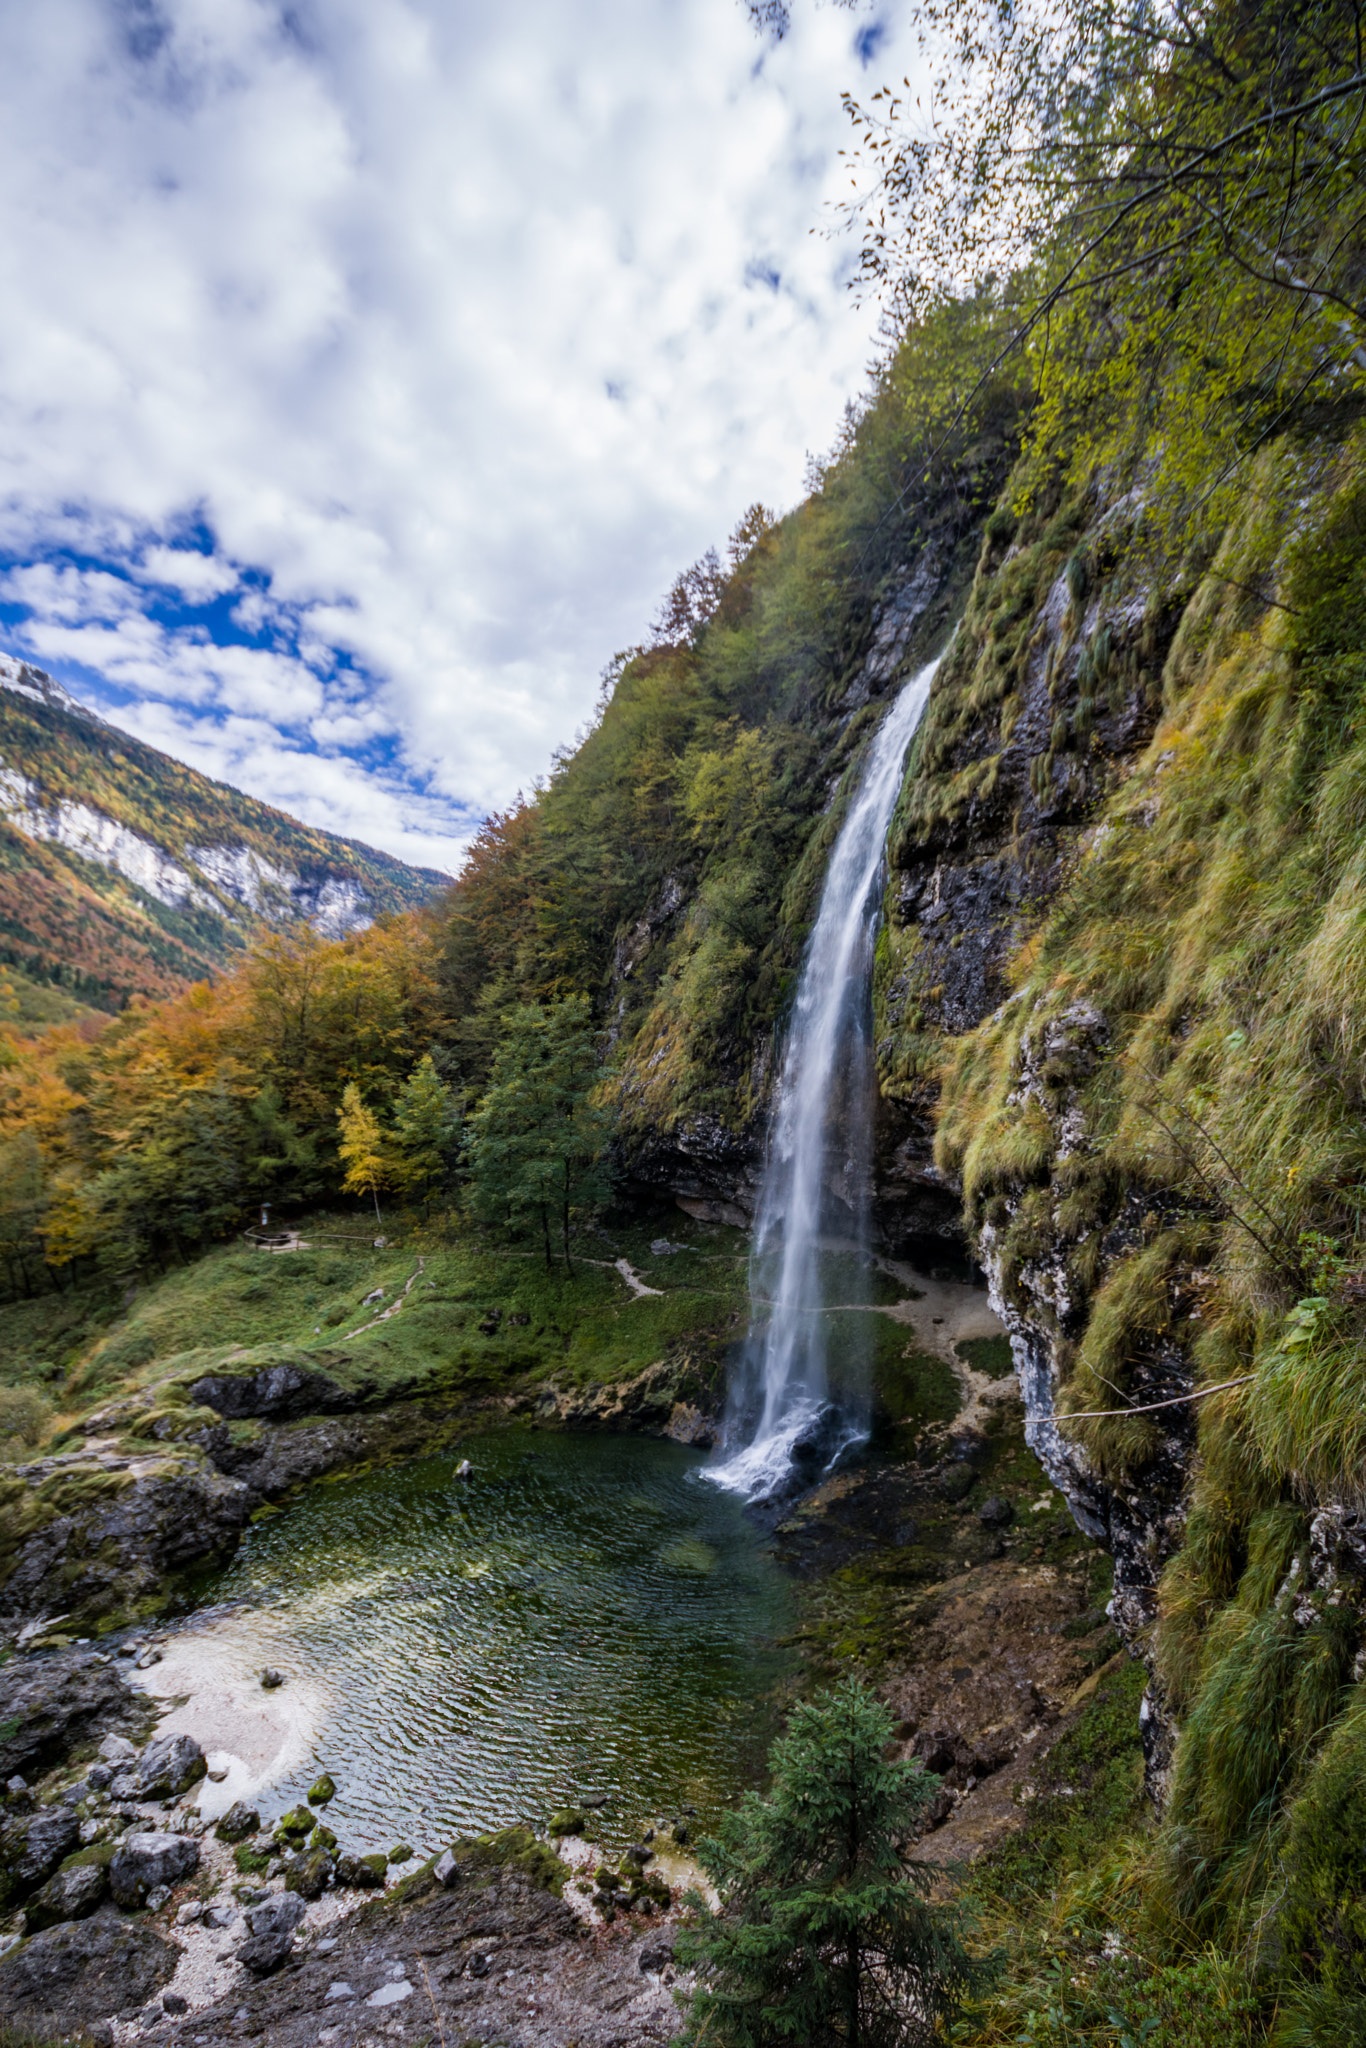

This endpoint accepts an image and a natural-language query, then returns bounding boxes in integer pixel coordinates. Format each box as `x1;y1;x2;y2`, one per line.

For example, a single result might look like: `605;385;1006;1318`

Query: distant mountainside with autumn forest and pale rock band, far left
0;655;446;1024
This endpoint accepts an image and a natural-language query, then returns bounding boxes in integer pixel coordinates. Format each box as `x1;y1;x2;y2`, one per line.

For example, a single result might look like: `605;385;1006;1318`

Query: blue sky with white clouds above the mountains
0;0;911;868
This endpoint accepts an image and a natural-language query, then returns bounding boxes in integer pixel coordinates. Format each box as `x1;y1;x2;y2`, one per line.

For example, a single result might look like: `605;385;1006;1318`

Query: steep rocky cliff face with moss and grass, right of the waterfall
897;430;1366;2017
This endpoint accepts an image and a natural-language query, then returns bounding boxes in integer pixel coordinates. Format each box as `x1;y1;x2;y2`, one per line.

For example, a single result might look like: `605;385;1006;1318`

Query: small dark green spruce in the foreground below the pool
680;1679;983;2048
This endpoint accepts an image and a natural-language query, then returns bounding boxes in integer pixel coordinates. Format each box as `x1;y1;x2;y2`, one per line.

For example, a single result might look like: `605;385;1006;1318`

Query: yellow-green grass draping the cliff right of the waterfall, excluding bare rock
881;411;1366;2015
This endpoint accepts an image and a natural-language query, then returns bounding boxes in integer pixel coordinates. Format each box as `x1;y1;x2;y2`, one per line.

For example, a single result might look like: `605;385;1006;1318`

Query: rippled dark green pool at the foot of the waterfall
211;1430;793;1851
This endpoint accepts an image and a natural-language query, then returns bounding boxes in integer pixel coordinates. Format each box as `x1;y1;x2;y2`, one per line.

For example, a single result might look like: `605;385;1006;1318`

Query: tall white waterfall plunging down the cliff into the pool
707;662;936;1499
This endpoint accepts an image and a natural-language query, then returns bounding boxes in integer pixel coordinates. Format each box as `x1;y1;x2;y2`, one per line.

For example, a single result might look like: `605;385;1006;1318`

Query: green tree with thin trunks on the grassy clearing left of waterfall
467;995;610;1272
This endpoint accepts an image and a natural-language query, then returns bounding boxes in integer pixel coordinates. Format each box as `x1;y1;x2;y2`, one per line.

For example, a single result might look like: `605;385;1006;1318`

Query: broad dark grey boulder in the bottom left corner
0;1915;180;2038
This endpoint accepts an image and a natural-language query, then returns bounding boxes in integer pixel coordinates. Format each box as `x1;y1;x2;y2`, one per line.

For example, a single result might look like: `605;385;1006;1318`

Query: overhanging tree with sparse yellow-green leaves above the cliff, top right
846;0;1366;528
